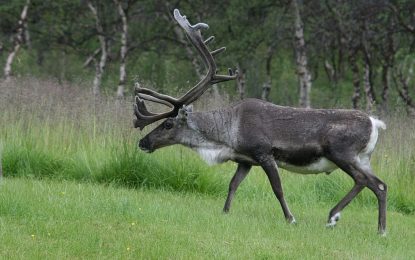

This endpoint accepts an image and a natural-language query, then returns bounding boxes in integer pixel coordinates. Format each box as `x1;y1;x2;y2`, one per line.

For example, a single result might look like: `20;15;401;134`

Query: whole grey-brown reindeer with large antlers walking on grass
134;9;387;234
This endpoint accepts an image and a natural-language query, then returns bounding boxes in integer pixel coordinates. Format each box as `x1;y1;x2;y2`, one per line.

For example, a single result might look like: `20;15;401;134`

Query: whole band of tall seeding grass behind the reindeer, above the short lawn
0;78;415;214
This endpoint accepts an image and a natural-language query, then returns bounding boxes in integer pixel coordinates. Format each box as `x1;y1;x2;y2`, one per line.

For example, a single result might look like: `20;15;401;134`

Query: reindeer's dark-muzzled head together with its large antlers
134;9;237;152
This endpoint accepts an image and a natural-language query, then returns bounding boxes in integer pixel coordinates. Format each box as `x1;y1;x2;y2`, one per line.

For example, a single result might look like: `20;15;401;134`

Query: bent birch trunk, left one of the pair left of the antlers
88;1;108;97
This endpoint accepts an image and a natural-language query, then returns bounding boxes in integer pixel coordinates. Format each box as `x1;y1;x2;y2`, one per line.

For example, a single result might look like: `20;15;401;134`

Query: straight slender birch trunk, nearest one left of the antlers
114;0;128;99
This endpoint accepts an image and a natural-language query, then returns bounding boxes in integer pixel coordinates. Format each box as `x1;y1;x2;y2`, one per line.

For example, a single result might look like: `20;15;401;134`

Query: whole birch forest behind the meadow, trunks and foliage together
0;0;415;112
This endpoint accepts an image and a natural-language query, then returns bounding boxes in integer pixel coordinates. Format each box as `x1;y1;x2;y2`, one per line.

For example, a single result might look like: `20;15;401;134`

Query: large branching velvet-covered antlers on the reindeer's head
134;9;237;129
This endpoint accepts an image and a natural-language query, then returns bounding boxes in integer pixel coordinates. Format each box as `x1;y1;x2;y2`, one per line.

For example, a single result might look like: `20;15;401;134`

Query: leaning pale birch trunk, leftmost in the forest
4;0;30;81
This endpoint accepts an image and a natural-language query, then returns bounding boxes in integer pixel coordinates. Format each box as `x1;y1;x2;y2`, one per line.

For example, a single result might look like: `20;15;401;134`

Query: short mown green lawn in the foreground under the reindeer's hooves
0;177;415;259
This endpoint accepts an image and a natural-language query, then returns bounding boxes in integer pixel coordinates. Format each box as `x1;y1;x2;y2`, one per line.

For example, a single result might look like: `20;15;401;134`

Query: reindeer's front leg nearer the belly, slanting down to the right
258;156;295;224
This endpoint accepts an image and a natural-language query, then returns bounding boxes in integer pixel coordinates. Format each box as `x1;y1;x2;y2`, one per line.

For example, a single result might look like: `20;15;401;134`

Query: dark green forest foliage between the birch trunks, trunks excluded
0;0;415;108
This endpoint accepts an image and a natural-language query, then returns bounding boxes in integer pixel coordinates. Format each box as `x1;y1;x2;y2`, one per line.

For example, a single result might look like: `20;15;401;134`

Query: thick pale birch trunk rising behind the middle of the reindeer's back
291;0;311;108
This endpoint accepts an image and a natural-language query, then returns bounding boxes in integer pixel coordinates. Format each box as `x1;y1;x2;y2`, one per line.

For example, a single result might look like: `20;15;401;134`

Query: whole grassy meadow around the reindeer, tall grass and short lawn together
0;78;415;259
